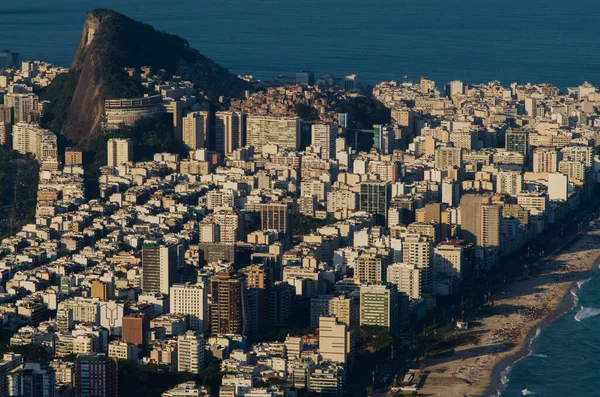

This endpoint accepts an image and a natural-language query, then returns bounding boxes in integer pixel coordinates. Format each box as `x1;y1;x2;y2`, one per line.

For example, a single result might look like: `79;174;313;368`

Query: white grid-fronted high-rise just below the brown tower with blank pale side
169;283;209;333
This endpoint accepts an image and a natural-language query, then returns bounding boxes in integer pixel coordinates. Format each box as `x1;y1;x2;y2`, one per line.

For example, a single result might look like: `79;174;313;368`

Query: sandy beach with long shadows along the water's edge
419;230;600;397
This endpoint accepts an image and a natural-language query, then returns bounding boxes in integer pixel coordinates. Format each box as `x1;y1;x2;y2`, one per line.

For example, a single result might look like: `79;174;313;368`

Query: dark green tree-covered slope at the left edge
0;146;40;236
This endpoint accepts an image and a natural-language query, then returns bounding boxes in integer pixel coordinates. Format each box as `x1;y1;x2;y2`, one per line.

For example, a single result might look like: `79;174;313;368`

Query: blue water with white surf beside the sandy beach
500;272;600;397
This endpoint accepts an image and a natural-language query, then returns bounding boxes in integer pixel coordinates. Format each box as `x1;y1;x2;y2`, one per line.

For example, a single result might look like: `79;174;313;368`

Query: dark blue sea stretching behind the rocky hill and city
0;0;600;88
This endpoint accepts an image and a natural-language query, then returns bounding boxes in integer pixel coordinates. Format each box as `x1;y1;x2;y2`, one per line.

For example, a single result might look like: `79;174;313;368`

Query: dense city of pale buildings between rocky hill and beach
0;53;600;397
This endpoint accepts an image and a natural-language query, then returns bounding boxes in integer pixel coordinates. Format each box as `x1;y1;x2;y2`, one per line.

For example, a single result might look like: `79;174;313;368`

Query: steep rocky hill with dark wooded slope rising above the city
43;9;249;146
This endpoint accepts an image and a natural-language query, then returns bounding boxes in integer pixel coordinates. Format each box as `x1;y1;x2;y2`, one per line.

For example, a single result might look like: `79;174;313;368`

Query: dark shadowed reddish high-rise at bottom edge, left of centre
73;354;119;397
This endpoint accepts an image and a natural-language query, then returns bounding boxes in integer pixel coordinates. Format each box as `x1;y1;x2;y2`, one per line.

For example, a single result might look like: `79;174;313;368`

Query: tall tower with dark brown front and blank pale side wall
142;240;183;294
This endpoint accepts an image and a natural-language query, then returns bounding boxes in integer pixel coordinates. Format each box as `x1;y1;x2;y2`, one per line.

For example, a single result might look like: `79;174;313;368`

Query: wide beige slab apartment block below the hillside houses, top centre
246;116;300;153
